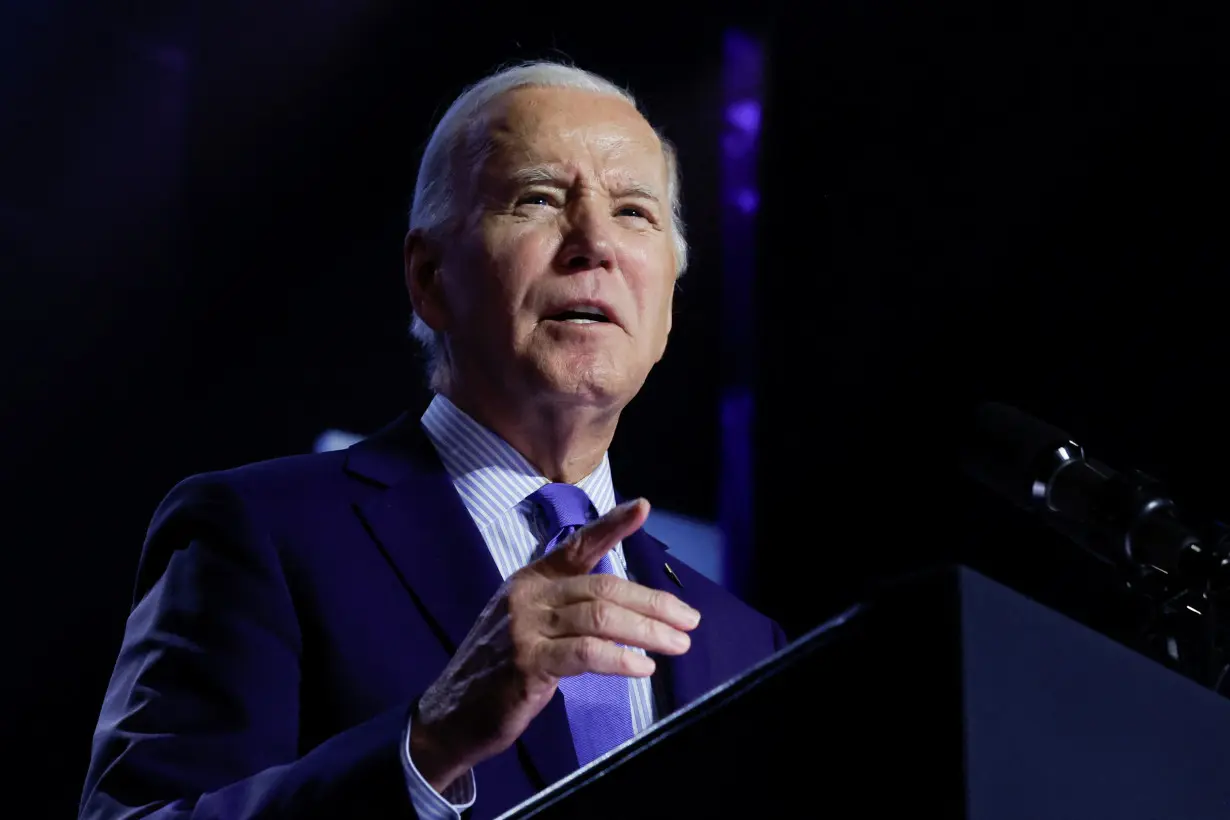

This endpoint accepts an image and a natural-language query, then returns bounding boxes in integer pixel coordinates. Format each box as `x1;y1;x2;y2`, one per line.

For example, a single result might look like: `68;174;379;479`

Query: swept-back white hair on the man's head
410;61;688;391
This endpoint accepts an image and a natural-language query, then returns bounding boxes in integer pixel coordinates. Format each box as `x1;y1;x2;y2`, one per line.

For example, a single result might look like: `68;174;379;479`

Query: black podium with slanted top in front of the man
503;567;1230;820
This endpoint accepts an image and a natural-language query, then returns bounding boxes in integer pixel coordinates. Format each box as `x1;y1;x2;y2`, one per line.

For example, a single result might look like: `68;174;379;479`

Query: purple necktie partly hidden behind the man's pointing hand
530;484;632;766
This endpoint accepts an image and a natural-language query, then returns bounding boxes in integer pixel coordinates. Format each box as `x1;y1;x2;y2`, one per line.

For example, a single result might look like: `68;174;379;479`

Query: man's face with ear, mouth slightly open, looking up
412;89;675;408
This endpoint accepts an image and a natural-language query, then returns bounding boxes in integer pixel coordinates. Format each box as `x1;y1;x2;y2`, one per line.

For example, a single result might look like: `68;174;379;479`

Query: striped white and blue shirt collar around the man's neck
422;393;615;527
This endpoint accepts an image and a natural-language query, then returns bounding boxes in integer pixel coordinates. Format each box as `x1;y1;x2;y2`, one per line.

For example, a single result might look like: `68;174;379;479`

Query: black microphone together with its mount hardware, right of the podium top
964;403;1230;692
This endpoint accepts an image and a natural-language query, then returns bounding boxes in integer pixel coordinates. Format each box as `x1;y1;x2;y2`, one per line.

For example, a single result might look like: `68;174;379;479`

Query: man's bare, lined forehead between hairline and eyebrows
474;89;667;183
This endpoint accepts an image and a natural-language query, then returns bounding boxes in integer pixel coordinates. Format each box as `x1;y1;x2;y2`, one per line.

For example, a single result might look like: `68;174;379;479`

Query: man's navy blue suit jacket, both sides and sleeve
81;414;785;819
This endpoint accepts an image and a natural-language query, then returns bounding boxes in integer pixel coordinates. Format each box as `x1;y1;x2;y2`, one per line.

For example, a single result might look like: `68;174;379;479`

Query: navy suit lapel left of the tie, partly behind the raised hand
347;414;577;789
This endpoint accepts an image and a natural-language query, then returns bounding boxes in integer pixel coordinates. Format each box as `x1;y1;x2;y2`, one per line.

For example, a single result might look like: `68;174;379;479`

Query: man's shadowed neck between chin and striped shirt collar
440;384;619;484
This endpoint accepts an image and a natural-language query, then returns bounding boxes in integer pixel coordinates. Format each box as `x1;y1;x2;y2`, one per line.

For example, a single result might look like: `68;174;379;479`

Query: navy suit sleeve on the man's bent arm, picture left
80;477;415;820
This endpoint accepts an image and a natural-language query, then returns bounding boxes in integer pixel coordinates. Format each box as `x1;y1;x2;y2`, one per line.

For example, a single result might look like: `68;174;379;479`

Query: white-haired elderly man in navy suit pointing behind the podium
81;63;785;818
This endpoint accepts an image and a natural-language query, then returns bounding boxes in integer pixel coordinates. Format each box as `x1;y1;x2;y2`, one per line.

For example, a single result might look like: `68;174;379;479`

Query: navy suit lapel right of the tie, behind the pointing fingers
624;530;712;719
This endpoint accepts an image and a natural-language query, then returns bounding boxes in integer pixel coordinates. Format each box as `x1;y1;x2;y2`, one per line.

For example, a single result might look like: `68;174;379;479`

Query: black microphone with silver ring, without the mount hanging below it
962;402;1230;588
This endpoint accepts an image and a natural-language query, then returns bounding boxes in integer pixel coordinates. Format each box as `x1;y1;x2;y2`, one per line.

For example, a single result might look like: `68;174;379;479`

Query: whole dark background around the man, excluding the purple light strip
0;0;1230;816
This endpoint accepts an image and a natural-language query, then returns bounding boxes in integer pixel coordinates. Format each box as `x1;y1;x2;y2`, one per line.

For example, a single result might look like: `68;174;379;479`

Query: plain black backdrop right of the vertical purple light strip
756;1;1230;631
